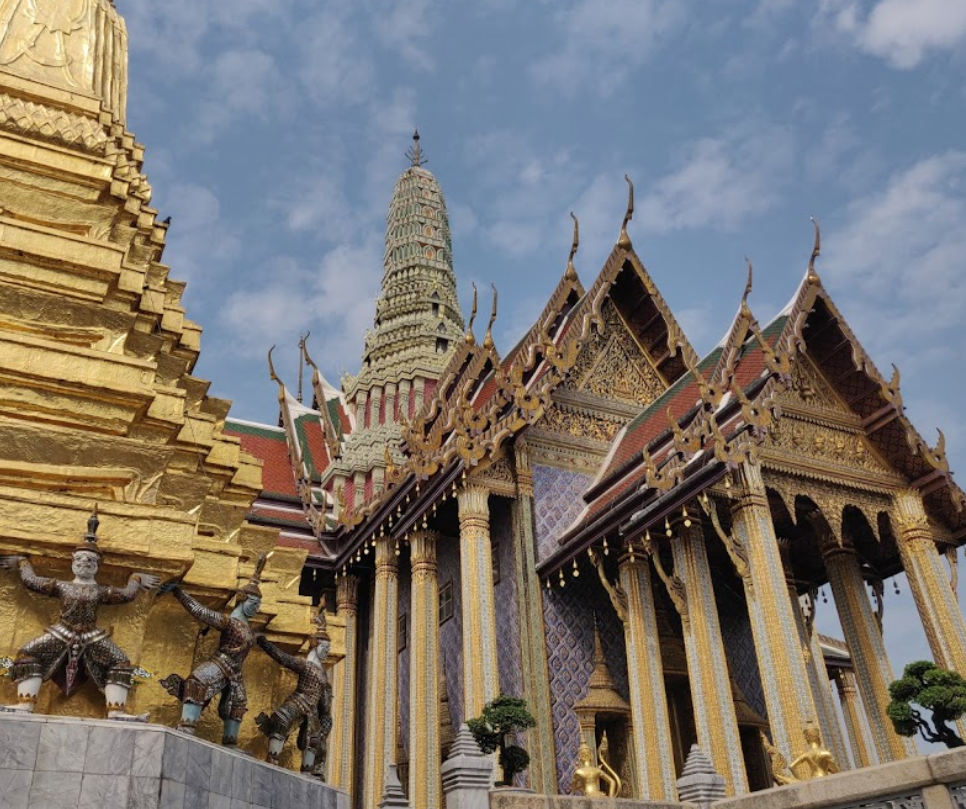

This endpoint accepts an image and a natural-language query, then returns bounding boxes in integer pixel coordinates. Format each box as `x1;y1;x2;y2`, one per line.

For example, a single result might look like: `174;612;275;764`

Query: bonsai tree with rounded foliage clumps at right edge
886;660;966;747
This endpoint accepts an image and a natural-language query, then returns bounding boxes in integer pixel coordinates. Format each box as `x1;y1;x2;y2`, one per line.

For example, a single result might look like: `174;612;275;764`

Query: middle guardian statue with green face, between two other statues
161;553;268;747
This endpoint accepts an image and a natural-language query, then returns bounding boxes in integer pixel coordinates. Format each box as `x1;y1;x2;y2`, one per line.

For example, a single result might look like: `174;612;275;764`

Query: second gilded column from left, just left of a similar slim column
362;537;399;807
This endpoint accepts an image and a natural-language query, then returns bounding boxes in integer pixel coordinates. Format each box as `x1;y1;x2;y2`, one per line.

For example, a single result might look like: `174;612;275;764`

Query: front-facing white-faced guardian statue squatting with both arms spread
0;509;160;719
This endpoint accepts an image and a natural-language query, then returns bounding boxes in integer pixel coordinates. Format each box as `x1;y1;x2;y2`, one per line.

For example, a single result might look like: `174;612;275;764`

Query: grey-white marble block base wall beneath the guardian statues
0;714;349;809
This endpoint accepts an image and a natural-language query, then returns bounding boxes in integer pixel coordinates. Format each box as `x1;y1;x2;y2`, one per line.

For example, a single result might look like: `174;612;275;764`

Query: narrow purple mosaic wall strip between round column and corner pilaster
490;497;524;697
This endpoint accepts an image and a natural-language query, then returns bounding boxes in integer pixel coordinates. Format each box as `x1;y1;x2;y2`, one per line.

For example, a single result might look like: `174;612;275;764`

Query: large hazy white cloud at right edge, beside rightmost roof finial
823;151;966;365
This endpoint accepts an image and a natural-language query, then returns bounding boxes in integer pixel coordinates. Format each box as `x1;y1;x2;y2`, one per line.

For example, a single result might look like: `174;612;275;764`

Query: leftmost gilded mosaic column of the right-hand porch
620;553;677;801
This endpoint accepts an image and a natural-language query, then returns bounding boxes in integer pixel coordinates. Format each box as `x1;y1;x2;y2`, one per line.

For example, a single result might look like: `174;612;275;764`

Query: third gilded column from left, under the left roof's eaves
409;531;441;809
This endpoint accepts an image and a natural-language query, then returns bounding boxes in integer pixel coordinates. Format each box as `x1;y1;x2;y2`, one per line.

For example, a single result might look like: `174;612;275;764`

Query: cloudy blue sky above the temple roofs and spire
125;0;966;696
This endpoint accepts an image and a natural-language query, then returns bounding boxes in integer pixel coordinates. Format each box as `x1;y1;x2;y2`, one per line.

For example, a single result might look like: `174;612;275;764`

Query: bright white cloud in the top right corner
819;0;966;70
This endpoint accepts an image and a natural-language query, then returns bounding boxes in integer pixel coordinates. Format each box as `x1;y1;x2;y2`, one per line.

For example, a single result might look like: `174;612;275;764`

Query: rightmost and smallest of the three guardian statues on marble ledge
255;601;332;780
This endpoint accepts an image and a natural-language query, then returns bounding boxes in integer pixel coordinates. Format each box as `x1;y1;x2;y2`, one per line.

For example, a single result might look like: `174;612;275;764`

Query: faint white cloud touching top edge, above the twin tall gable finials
530;0;687;95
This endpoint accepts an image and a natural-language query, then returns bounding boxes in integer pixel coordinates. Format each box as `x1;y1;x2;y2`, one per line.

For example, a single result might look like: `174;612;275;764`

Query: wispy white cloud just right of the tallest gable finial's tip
638;127;794;233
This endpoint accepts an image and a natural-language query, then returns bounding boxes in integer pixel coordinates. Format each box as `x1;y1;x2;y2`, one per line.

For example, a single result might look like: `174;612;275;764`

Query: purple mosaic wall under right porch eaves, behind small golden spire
542;567;629;794
